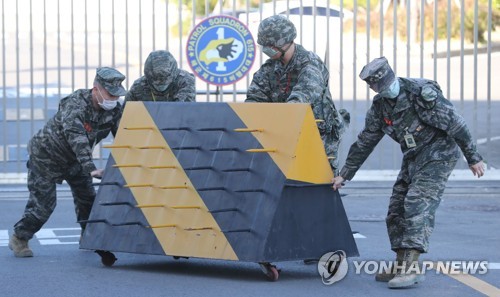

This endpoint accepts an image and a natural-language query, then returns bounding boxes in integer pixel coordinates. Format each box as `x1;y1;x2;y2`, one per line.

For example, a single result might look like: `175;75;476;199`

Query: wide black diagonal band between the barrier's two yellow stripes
144;102;285;261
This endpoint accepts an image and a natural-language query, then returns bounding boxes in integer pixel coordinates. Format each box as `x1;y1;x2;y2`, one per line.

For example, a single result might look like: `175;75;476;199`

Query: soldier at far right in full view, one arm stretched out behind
333;57;484;288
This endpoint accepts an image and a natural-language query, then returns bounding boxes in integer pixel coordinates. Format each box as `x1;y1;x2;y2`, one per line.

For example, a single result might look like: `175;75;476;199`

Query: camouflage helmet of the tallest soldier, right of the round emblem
257;15;297;47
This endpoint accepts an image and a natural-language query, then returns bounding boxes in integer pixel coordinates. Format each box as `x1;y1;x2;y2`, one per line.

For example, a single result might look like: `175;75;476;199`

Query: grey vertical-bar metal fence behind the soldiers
0;0;500;173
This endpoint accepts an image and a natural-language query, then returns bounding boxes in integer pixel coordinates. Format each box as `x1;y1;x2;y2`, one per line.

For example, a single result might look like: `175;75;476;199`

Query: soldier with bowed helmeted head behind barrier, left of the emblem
125;50;196;102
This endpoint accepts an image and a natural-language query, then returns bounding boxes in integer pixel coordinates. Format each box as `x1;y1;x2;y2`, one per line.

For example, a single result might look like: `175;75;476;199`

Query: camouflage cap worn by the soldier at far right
359;57;396;93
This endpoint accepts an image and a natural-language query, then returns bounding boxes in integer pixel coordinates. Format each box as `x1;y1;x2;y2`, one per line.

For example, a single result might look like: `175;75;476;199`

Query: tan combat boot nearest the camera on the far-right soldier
388;249;425;289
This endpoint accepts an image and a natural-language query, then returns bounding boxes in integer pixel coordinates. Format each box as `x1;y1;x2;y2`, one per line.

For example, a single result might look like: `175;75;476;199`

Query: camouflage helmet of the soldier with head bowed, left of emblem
144;50;179;92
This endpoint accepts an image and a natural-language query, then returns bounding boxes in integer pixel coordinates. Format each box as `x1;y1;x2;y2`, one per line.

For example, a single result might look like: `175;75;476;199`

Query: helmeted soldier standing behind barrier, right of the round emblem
245;15;349;174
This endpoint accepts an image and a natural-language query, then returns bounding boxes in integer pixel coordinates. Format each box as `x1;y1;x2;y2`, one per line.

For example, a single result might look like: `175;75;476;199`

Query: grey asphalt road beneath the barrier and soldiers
0;180;500;297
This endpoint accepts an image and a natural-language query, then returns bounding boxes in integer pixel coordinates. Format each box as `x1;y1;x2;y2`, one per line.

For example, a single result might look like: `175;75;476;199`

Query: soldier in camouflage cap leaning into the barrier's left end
9;67;126;257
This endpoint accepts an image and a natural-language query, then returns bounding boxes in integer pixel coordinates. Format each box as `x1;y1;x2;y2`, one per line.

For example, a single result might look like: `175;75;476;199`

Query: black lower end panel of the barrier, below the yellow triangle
261;181;359;262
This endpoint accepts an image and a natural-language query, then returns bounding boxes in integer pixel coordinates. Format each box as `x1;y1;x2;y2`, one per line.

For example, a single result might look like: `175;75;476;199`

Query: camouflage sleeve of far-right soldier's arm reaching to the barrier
339;105;385;180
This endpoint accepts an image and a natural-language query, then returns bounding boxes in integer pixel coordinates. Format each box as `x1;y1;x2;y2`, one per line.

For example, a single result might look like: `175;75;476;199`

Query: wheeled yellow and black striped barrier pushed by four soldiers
81;102;358;262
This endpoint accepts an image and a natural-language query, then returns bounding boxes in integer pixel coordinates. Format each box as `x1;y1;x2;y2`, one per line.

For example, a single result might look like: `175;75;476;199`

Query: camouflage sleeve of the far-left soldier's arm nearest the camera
60;98;96;174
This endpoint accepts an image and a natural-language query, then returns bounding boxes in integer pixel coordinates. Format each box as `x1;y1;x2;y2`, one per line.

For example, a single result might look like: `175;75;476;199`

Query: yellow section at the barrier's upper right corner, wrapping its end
229;103;333;183
